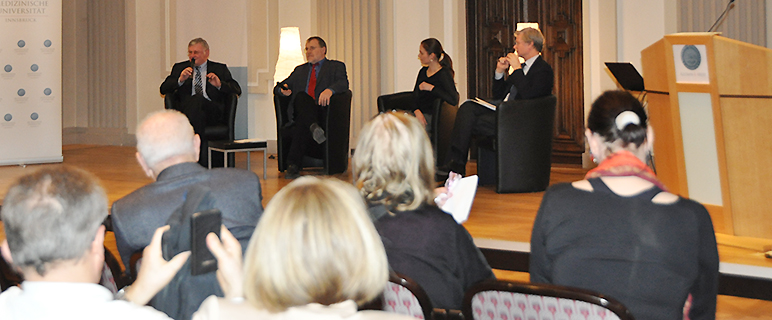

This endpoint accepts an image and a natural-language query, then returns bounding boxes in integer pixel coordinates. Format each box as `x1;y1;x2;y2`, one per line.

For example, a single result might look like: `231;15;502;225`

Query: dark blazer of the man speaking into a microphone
161;60;241;103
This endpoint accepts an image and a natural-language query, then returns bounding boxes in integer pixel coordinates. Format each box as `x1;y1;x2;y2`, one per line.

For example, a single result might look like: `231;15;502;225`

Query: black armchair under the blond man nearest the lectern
477;95;557;193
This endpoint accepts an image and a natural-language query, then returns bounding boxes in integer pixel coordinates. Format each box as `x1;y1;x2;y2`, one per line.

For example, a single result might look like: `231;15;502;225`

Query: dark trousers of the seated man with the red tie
285;92;326;168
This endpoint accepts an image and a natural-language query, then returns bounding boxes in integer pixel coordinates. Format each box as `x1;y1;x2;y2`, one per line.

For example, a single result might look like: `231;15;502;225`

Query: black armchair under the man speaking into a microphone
164;91;239;167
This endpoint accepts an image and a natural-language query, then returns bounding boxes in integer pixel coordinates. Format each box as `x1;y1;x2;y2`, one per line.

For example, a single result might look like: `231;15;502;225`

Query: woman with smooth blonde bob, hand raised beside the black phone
193;177;411;320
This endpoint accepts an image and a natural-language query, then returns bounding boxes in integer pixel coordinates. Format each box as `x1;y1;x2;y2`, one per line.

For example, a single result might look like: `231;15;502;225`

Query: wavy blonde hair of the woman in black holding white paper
352;112;434;211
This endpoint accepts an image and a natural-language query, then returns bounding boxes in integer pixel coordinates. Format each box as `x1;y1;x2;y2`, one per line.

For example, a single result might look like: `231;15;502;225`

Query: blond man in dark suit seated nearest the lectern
438;28;555;175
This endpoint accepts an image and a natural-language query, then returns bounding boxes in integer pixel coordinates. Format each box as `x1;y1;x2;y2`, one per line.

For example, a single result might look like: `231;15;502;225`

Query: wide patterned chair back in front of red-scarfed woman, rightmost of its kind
463;280;633;320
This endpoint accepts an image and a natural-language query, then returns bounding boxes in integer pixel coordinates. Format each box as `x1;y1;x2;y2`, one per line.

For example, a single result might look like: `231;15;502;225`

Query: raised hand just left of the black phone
125;226;190;306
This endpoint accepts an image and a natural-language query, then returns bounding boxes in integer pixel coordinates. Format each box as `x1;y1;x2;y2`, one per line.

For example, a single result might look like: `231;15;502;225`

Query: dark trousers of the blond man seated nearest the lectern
448;101;496;164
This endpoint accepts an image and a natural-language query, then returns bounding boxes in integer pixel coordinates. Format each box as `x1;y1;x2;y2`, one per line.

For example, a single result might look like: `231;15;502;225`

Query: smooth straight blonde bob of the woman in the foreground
244;177;389;312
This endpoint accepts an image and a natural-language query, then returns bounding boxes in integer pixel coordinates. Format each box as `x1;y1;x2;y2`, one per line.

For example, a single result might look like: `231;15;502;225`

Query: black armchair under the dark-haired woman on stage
378;91;458;164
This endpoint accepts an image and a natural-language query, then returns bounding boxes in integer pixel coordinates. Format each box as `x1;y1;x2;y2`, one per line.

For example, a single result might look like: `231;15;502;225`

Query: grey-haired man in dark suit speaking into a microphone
161;38;241;165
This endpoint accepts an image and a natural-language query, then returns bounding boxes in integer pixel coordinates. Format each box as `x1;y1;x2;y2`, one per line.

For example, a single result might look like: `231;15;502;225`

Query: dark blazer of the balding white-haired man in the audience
112;162;263;264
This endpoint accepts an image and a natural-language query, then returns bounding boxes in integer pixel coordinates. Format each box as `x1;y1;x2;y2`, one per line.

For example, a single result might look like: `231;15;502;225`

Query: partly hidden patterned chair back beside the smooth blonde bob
383;273;432;319
